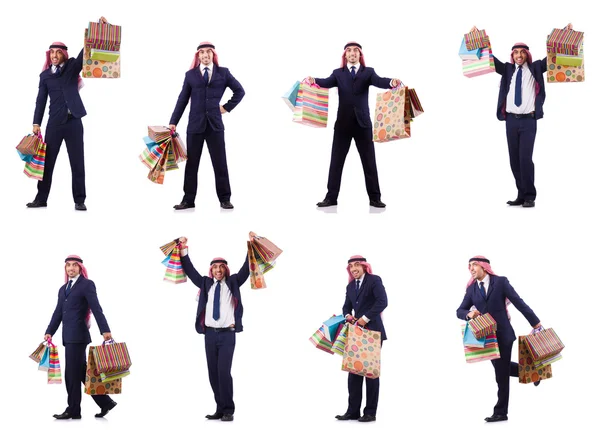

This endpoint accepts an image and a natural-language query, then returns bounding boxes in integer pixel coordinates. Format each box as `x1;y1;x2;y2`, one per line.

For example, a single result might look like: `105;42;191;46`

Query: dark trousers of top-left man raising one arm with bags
35;118;85;203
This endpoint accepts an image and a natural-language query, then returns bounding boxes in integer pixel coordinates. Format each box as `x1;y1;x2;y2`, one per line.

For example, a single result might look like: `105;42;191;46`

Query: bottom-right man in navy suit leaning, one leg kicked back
456;255;542;422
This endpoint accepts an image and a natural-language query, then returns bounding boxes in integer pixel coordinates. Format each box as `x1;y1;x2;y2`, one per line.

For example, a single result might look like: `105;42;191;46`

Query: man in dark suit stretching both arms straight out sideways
308;42;400;208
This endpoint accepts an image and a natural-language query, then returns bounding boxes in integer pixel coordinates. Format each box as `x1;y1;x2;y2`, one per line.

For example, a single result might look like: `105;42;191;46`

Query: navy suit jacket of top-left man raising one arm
33;49;86;127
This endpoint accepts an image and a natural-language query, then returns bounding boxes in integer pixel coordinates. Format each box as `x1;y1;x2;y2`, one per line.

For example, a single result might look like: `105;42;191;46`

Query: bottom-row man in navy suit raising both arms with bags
179;232;256;421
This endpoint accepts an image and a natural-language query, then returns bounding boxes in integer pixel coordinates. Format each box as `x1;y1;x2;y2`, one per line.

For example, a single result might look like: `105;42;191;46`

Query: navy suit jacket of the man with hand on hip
169;64;245;133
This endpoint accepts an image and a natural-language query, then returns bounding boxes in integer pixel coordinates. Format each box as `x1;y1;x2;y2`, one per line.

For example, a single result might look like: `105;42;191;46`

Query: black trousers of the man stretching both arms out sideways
326;120;381;201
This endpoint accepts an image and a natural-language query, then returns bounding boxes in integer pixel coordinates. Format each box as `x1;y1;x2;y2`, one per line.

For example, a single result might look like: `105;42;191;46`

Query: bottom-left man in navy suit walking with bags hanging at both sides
44;255;117;420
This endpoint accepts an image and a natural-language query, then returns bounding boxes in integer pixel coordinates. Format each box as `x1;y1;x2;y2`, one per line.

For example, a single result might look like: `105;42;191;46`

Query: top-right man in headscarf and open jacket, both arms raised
494;24;573;208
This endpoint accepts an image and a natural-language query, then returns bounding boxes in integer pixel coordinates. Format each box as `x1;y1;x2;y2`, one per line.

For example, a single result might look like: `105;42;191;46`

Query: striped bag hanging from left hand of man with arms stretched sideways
292;82;329;127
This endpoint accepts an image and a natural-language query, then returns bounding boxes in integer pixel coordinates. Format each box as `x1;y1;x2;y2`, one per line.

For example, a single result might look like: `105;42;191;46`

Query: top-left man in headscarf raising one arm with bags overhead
27;17;107;211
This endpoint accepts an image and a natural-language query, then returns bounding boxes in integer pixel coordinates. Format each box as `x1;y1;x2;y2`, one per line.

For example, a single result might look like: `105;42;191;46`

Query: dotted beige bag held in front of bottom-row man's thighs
342;325;381;379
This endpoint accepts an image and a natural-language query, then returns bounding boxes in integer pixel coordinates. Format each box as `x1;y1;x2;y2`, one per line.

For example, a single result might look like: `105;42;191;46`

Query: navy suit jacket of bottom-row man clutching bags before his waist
342;273;387;340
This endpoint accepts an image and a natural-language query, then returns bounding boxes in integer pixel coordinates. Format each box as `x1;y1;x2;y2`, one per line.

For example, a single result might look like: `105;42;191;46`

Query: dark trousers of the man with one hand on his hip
183;125;231;203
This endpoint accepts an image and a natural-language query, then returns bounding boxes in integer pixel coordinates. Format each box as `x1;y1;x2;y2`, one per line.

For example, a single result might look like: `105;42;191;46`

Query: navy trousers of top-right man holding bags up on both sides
506;114;537;200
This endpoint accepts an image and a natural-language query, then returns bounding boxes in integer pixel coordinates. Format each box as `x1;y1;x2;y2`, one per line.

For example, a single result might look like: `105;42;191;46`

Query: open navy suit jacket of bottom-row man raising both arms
181;255;250;334
